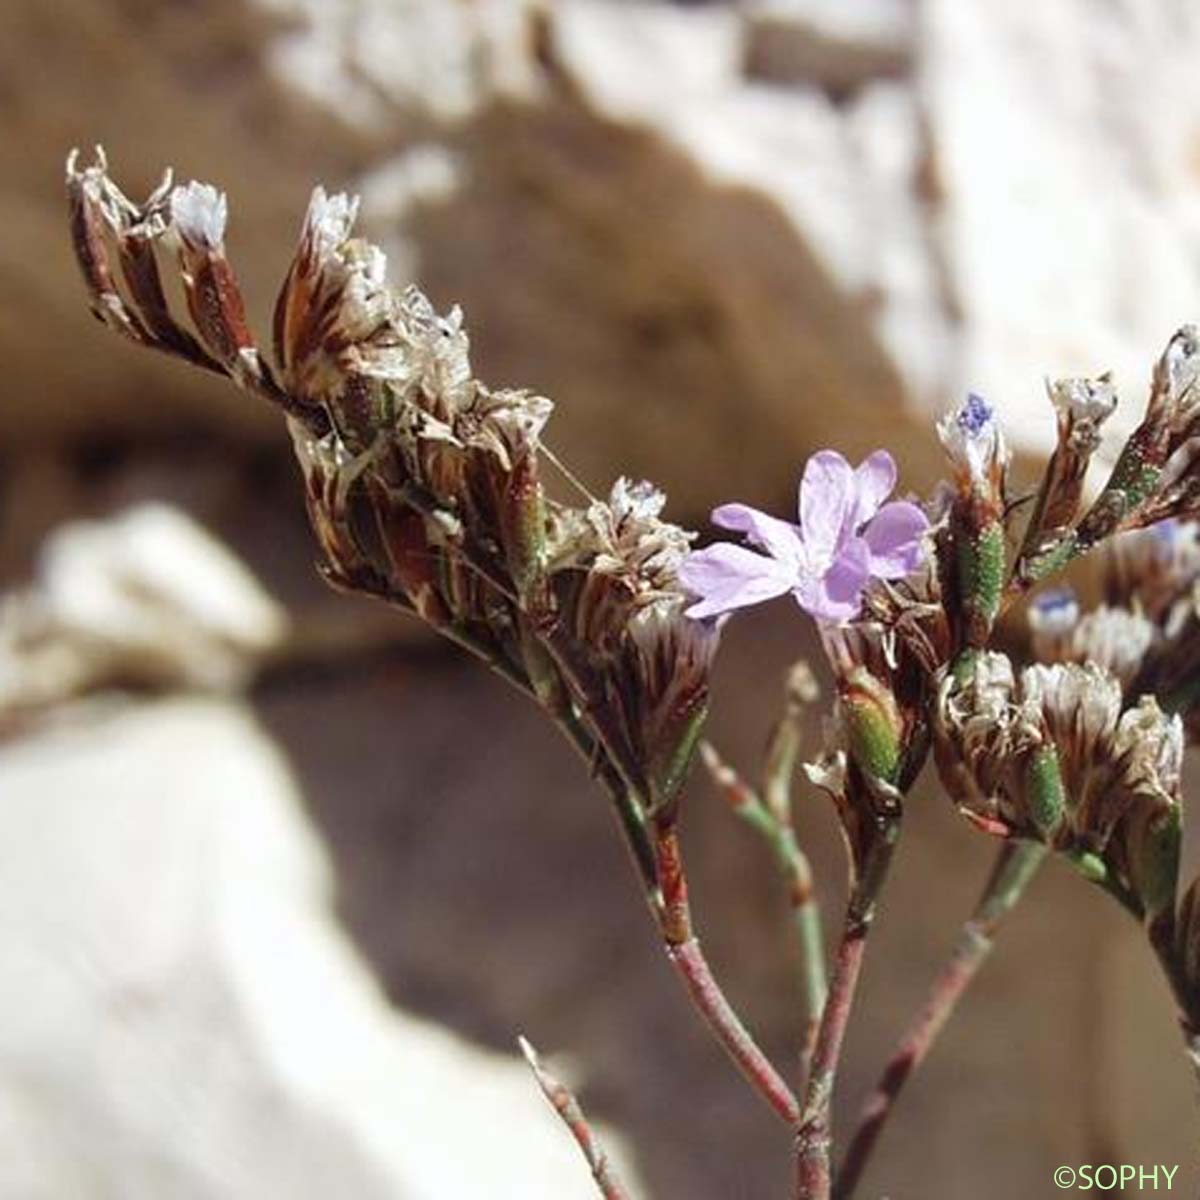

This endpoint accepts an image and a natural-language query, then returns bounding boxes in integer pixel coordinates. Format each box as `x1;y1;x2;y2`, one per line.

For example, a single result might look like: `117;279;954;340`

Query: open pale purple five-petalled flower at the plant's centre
679;450;929;620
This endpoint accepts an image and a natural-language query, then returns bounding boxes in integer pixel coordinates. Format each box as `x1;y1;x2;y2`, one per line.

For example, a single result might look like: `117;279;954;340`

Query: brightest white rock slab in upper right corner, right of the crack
920;0;1200;446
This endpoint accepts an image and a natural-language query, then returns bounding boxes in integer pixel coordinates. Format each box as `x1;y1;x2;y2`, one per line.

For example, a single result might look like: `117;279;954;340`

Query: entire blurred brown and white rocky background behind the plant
0;0;1200;1200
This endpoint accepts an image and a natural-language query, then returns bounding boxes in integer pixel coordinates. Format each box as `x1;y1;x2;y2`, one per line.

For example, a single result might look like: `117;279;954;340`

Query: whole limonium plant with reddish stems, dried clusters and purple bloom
67;152;1200;1200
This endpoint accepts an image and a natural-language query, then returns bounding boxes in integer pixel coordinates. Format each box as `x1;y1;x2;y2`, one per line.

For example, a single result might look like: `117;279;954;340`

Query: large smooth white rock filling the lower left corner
0;701;638;1200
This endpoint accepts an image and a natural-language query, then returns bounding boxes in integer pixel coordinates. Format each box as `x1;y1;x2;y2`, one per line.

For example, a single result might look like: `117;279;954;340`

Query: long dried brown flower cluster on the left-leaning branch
67;155;718;811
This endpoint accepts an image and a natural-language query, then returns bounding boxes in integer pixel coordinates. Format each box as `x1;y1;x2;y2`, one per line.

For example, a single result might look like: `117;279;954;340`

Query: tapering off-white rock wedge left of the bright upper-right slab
554;0;952;409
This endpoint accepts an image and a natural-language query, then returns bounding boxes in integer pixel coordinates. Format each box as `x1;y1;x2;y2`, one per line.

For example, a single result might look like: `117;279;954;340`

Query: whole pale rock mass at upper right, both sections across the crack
554;0;1200;458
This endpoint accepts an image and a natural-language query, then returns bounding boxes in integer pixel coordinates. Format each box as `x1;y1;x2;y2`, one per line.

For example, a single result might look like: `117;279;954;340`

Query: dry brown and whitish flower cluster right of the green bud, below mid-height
934;652;1183;918
